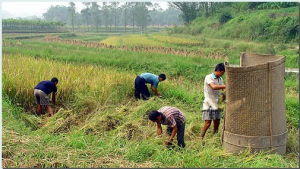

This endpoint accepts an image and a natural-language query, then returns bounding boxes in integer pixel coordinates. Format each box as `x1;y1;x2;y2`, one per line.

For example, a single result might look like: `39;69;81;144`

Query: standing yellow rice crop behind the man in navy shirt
2;55;134;107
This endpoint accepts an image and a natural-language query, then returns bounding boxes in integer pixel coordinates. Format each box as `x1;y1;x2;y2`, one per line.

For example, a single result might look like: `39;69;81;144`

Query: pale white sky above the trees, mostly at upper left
2;0;168;18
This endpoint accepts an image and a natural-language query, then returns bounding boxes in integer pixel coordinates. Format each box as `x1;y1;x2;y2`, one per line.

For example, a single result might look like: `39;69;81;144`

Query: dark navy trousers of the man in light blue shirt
134;76;150;100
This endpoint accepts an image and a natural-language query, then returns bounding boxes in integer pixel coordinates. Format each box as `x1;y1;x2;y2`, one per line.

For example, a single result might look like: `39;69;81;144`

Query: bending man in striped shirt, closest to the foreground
149;106;185;148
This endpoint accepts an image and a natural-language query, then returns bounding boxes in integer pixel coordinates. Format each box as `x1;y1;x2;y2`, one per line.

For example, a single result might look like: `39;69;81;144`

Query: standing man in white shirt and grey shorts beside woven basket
201;63;225;139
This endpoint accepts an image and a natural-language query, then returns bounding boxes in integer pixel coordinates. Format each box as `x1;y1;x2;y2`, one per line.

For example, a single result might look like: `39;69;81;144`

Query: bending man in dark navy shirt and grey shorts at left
34;77;58;116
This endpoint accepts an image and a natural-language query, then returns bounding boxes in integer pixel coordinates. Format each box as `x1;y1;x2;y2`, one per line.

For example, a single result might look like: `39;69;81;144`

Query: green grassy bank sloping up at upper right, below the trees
169;7;299;43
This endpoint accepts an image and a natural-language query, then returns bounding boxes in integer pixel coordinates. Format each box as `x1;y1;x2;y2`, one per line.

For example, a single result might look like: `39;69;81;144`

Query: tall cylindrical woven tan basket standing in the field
222;53;287;154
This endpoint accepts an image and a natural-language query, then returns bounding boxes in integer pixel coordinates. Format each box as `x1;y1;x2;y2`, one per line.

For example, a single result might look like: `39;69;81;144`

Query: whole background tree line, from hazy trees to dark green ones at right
3;2;298;32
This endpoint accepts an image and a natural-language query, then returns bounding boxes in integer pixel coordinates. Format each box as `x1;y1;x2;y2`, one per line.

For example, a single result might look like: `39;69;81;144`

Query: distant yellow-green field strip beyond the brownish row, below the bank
4;33;299;68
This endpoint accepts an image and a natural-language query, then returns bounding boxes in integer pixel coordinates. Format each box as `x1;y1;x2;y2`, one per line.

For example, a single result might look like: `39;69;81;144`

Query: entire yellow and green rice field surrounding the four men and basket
2;34;299;168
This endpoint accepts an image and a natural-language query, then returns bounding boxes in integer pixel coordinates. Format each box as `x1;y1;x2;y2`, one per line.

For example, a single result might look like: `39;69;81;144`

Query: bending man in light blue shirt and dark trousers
134;73;166;100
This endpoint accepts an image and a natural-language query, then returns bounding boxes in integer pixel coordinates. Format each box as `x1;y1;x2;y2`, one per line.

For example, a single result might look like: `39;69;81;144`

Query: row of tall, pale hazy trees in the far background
43;2;183;32
